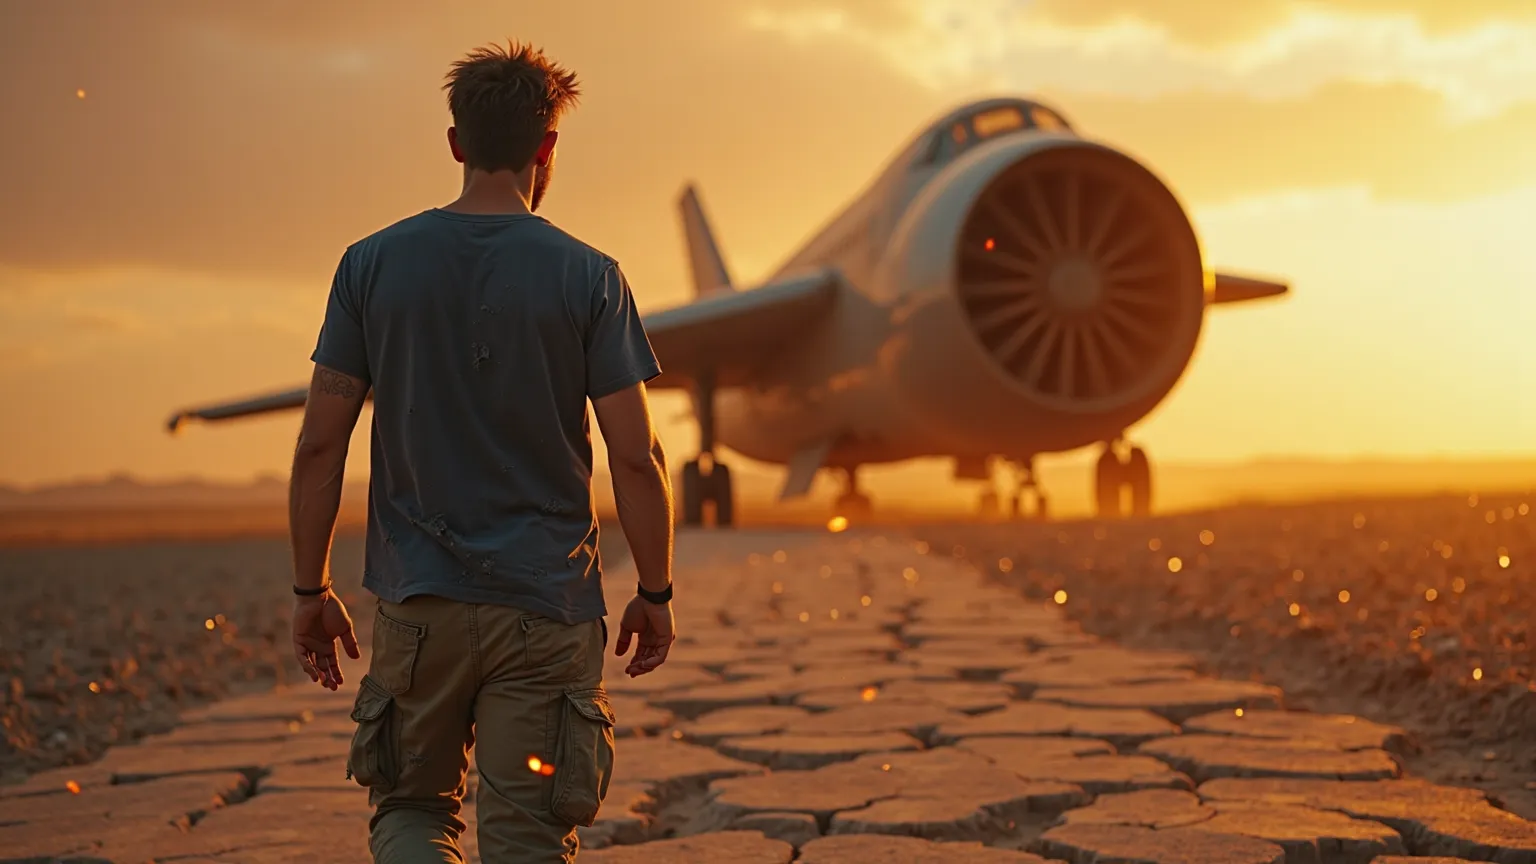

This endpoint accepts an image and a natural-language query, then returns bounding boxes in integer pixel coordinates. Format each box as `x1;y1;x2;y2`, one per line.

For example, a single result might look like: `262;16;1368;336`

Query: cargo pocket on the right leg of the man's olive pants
550;687;614;827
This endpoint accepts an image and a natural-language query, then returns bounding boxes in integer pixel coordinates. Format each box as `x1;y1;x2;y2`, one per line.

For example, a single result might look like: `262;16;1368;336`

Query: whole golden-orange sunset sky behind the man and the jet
0;0;1536;484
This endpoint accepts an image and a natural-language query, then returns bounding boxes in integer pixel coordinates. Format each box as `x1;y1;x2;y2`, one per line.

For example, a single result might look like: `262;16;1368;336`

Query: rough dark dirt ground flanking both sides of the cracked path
0;497;1536;816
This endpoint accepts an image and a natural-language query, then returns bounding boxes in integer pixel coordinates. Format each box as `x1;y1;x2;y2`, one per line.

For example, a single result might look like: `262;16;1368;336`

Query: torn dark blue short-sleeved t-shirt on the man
312;209;660;624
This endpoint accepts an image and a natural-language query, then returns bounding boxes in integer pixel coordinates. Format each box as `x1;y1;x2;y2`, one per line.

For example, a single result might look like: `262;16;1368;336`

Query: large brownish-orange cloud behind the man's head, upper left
0;0;931;282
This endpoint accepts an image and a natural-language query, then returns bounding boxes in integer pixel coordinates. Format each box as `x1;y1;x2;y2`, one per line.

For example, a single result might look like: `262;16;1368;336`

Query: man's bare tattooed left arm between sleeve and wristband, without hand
289;364;369;587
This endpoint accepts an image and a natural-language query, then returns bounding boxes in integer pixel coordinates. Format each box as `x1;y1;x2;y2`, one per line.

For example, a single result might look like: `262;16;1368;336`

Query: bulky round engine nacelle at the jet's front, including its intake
876;134;1204;457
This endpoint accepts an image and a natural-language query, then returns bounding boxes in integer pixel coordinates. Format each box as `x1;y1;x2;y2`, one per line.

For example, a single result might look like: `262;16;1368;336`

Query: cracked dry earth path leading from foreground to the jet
0;533;1536;864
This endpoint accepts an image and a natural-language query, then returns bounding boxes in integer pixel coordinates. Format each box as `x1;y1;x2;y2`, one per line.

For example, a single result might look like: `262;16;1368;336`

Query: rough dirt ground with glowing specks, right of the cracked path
919;495;1536;818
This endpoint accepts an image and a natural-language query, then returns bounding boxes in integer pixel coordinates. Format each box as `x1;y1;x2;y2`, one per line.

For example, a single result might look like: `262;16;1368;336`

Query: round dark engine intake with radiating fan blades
955;146;1204;414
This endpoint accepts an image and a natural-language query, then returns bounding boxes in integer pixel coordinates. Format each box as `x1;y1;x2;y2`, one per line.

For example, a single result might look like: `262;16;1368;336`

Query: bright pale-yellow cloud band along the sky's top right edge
748;0;1536;118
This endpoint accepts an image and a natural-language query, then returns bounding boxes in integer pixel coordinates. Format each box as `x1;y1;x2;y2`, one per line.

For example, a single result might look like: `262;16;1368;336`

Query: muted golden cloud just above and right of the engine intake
1058;83;1536;203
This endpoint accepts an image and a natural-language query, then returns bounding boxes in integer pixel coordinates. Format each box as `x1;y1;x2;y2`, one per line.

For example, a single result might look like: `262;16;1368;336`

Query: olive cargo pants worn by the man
347;596;614;864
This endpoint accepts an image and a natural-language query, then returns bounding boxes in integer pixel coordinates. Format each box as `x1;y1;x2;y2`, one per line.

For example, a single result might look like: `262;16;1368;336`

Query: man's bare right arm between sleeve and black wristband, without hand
593;384;673;590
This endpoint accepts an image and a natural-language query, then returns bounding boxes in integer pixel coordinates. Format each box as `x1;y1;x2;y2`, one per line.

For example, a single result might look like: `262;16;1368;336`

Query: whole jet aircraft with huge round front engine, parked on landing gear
169;98;1289;526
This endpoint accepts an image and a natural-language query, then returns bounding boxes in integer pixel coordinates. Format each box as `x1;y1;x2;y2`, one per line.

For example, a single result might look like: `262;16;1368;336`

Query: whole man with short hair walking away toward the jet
290;43;674;864
